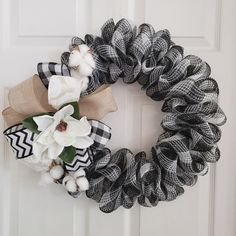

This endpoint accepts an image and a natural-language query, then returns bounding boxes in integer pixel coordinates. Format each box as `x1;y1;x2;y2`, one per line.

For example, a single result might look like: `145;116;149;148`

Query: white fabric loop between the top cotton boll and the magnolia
48;75;88;109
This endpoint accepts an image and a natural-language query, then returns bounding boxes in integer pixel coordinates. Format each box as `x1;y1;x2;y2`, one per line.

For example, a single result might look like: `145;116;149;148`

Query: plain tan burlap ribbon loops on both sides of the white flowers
2;75;117;126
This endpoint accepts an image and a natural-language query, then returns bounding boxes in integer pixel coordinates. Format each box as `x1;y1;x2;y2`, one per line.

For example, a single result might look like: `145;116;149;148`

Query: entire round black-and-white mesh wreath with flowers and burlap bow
3;19;226;212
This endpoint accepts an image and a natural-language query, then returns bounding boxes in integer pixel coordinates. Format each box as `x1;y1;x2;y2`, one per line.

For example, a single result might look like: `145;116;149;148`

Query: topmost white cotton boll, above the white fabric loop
68;44;95;77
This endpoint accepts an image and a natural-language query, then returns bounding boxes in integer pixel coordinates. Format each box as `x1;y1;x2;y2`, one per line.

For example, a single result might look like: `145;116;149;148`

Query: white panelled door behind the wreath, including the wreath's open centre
0;0;236;236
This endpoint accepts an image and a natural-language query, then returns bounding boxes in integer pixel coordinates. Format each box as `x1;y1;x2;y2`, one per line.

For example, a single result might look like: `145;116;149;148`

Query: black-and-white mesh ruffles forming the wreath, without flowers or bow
39;19;226;212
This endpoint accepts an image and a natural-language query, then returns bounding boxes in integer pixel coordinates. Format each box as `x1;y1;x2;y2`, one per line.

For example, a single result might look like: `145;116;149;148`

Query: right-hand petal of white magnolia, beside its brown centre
64;116;91;137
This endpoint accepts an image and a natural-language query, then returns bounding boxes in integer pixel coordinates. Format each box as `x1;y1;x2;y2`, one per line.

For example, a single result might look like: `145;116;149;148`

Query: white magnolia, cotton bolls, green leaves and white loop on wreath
23;45;95;193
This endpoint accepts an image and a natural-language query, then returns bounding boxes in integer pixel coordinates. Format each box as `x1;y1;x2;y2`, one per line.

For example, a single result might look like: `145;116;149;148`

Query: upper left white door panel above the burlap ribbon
18;0;77;37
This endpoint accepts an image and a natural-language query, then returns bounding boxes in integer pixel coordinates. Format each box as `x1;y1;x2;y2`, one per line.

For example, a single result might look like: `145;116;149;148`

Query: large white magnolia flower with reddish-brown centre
33;105;93;160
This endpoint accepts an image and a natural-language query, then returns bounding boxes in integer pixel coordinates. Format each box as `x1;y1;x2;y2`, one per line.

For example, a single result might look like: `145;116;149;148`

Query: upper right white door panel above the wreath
135;0;222;50
